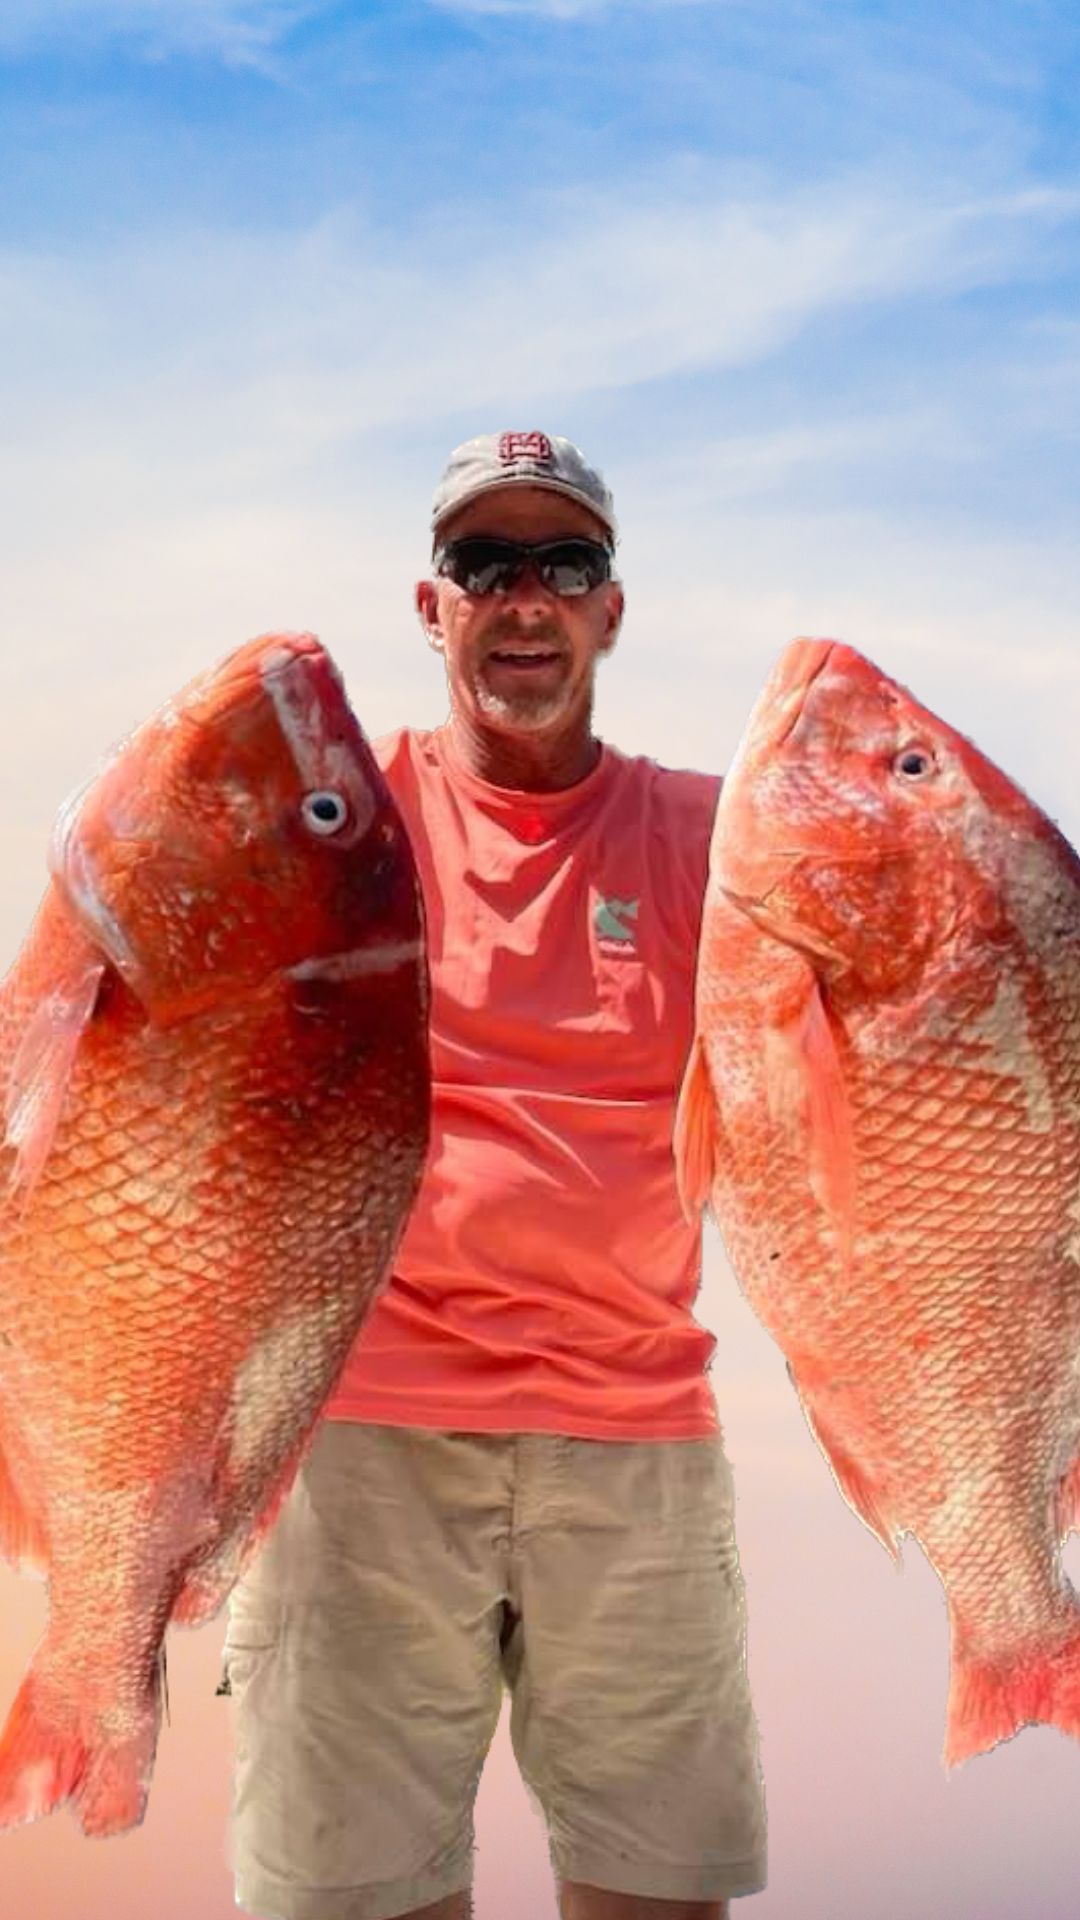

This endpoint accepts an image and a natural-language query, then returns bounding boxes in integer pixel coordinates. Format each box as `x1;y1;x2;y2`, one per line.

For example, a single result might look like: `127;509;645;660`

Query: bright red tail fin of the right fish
942;1624;1080;1766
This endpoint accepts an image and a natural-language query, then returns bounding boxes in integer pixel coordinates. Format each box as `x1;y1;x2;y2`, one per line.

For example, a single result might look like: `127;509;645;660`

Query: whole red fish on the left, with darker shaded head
0;634;429;1834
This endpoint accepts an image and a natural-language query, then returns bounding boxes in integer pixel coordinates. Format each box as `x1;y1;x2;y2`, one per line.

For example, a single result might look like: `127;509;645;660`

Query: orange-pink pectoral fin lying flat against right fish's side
767;990;855;1267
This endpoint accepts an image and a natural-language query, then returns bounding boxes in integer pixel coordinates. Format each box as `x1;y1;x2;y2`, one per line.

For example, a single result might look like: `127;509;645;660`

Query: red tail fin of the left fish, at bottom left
0;1663;160;1836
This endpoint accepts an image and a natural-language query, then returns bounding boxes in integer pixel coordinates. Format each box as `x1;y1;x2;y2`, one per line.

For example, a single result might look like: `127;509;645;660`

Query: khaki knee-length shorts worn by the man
225;1421;765;1920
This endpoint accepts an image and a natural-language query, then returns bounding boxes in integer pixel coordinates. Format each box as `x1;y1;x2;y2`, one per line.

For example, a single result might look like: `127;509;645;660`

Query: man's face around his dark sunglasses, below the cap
417;484;623;735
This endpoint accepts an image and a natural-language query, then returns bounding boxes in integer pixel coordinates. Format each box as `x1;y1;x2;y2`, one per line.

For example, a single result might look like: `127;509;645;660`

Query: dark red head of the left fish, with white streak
50;634;421;1021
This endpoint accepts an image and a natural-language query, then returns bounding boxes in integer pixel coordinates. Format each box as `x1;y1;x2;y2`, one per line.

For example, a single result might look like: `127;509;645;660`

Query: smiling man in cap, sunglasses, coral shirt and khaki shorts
227;432;765;1920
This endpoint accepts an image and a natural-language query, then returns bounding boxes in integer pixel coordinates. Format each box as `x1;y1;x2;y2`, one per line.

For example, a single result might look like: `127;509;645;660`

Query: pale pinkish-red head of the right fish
713;639;1055;991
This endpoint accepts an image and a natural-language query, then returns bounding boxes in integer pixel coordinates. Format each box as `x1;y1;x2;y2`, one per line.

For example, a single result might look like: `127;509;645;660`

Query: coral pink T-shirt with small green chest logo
327;730;721;1440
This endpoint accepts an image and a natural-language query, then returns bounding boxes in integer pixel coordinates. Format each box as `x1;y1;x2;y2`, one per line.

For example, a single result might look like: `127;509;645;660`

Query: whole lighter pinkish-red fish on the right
676;639;1080;1764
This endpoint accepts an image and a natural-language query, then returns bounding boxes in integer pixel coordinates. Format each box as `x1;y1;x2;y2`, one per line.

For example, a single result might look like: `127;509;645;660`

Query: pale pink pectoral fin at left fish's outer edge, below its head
4;945;106;1200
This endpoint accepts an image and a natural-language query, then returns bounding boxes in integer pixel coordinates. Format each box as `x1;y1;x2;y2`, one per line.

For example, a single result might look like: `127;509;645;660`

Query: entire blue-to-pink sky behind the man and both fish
0;0;1080;1920
